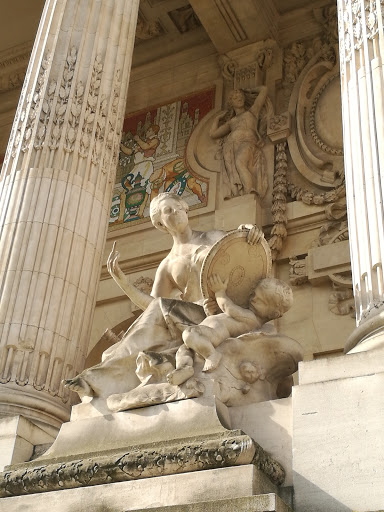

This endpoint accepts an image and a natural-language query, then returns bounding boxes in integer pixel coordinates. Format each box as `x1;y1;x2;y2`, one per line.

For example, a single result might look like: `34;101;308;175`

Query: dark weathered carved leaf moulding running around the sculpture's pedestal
0;431;285;497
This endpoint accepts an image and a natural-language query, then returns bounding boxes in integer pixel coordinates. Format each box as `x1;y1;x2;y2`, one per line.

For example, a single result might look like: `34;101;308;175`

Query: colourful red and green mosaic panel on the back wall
109;89;215;230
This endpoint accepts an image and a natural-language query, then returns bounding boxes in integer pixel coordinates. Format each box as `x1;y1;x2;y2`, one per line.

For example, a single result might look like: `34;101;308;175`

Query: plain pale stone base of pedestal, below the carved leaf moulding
0;465;290;512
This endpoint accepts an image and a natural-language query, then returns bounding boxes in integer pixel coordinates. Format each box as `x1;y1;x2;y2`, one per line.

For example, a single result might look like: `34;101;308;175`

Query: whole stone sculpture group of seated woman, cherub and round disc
65;193;302;412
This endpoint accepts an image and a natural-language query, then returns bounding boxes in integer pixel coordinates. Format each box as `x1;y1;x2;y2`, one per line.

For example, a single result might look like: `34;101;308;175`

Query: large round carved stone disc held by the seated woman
200;230;272;308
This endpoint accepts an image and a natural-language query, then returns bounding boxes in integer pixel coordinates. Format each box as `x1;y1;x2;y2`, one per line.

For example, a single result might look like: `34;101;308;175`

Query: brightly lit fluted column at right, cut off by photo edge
338;0;384;351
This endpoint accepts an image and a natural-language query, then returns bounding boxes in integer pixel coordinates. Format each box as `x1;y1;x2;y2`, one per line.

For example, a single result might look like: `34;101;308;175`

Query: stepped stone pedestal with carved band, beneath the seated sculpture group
0;397;291;512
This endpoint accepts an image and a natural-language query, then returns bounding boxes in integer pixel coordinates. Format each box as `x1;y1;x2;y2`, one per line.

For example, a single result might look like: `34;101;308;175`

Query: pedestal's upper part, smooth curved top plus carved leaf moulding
0;399;285;503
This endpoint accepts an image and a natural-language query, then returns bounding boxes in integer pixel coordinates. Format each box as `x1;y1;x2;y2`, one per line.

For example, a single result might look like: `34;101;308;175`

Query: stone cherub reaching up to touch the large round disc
167;274;293;385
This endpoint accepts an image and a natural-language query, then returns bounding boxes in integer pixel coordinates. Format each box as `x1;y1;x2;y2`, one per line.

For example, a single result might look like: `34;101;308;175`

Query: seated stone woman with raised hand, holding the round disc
65;193;263;400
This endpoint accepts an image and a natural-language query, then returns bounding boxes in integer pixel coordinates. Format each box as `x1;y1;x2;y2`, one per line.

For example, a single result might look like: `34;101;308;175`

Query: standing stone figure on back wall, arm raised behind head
210;86;268;199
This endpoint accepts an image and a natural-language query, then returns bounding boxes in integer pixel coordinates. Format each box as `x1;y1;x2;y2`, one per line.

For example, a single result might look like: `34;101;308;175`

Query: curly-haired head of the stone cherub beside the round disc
249;277;293;322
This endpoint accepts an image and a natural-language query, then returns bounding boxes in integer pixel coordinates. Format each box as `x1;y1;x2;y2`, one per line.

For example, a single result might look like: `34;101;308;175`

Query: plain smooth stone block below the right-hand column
292;350;384;512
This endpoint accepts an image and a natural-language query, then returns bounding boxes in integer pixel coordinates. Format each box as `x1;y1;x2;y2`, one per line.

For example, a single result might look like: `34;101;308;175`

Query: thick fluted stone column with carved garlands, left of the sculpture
0;0;139;426
